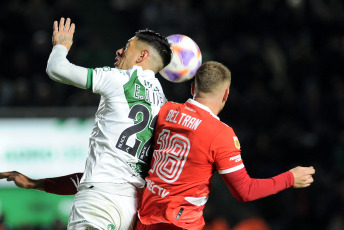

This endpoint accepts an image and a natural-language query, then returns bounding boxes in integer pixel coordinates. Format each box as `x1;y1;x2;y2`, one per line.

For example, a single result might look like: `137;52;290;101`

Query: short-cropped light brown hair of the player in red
195;61;231;93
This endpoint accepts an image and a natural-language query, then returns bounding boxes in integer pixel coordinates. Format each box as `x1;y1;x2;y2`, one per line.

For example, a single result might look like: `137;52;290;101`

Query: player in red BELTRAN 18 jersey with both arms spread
0;62;315;230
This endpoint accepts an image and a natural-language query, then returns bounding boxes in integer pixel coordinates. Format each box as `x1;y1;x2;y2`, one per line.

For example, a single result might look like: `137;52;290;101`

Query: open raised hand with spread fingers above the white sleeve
53;18;75;51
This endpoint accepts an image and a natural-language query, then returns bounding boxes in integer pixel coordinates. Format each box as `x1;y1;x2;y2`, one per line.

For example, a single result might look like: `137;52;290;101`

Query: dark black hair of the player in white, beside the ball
135;29;172;67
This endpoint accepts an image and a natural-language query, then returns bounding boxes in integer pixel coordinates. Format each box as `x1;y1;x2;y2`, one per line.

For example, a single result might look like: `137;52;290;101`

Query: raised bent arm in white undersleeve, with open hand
46;18;92;89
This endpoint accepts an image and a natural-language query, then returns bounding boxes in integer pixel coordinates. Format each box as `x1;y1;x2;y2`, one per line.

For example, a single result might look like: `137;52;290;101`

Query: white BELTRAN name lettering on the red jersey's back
166;109;202;130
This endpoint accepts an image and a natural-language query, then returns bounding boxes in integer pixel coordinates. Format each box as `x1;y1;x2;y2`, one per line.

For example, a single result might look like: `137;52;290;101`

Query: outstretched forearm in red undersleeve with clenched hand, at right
221;166;315;202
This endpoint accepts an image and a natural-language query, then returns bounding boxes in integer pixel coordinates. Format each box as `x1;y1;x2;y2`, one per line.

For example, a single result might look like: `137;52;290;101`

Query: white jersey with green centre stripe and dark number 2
81;66;166;188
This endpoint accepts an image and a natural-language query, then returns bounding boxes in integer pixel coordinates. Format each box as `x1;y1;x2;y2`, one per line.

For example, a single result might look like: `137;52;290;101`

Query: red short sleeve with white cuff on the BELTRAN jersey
212;127;244;174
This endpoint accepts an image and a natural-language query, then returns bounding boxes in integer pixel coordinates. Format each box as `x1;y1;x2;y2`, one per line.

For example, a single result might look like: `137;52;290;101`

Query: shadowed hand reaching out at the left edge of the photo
0;171;44;191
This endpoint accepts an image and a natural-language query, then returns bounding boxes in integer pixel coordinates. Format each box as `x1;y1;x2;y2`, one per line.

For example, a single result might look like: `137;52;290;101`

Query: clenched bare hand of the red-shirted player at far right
289;166;315;188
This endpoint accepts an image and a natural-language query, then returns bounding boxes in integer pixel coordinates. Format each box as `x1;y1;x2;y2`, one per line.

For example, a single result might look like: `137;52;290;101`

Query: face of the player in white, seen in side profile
115;37;140;70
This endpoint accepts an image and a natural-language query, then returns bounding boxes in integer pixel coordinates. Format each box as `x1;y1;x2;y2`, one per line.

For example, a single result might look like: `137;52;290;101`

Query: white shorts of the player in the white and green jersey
67;183;138;230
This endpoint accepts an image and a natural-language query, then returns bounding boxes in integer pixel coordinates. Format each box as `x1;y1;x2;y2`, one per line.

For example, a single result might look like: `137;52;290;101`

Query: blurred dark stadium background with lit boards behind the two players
0;0;344;230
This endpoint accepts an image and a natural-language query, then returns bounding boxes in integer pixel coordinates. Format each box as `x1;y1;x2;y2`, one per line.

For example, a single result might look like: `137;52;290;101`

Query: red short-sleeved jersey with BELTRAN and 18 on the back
139;99;244;228
